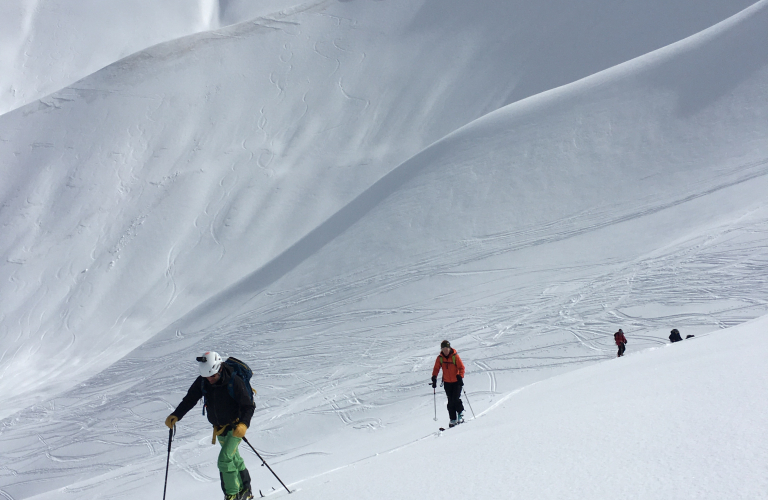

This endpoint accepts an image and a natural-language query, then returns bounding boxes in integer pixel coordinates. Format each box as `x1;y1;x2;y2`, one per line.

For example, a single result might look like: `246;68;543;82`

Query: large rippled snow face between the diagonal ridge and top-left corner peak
0;0;760;414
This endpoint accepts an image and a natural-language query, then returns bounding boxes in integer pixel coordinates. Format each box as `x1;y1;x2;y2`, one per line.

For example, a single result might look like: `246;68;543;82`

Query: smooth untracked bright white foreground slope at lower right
280;317;768;500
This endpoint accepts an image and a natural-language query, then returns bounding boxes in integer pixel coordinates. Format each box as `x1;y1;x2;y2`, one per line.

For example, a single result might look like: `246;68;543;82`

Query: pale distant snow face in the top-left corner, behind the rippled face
0;0;306;114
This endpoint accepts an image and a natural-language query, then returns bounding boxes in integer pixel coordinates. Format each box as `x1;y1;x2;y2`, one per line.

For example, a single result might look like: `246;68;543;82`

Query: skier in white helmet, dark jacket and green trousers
165;351;254;500
